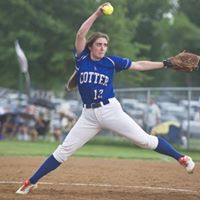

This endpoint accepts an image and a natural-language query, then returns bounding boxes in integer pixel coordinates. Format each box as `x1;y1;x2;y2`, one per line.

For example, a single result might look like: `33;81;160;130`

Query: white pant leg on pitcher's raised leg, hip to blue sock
102;98;158;149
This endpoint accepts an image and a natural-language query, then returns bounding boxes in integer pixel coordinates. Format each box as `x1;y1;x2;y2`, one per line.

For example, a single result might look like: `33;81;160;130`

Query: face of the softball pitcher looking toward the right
89;38;108;60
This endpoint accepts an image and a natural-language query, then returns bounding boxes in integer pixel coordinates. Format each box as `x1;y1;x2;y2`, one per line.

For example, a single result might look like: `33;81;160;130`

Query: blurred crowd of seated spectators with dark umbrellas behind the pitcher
0;90;77;141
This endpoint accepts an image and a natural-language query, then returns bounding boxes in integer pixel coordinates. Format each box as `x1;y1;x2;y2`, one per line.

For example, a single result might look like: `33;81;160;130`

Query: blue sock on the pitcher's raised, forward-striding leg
155;137;183;160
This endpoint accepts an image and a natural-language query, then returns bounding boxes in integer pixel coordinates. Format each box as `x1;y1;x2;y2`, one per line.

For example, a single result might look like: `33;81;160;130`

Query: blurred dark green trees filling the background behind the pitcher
0;0;200;90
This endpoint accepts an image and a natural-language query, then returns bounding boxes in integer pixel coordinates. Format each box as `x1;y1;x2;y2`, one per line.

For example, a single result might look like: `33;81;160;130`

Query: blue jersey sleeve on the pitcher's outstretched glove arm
110;56;132;72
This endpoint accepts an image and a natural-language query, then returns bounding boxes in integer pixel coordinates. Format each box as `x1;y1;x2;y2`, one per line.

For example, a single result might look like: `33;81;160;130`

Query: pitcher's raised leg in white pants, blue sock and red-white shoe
103;99;194;173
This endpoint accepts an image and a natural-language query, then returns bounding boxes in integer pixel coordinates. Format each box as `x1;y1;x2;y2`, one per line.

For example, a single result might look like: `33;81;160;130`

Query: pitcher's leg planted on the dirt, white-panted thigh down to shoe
16;110;101;194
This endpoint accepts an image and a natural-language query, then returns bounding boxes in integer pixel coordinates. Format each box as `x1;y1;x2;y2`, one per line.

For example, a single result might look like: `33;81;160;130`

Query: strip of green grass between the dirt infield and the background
0;136;200;161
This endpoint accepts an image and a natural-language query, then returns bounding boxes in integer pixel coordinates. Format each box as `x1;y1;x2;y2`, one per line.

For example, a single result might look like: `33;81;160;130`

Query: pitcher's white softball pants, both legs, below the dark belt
53;98;158;163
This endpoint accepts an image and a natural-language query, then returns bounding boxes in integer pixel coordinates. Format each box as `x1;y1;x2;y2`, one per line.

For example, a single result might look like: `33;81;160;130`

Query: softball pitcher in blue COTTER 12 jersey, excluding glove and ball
16;4;195;194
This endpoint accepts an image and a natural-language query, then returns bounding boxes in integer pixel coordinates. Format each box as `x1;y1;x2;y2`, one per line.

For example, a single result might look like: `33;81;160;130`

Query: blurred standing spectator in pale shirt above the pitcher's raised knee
143;97;160;133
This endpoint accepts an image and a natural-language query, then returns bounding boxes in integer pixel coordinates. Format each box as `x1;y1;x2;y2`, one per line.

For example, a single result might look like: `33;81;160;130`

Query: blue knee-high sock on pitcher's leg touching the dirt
29;155;61;184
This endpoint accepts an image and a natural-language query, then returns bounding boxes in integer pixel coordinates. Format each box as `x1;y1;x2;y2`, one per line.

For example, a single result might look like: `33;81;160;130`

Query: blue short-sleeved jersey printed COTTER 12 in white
75;49;132;104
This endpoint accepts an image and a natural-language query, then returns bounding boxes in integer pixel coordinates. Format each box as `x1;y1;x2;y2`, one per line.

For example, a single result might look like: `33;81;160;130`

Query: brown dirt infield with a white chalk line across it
0;157;200;200
